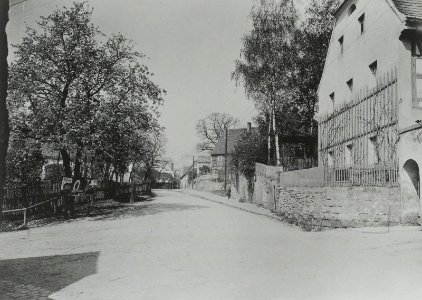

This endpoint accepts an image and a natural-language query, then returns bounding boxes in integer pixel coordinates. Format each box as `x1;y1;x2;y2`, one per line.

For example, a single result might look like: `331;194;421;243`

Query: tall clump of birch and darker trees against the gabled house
232;0;339;164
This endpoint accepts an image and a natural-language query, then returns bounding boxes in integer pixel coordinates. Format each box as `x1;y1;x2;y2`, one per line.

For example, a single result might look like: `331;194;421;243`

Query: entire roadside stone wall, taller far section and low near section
252;165;406;230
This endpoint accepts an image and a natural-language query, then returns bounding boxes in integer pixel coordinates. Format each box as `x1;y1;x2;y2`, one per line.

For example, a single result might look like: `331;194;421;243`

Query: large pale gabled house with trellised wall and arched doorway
318;0;422;220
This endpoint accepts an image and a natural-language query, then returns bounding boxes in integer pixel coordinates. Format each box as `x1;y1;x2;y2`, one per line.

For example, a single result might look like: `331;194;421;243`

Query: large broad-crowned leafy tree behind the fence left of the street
9;3;165;177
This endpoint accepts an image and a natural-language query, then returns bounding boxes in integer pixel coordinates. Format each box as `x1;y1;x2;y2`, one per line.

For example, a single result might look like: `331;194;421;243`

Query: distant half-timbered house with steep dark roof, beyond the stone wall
211;123;252;180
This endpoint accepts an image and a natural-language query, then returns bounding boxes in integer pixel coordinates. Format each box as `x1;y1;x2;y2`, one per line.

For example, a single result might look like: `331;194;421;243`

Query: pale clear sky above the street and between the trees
7;0;301;160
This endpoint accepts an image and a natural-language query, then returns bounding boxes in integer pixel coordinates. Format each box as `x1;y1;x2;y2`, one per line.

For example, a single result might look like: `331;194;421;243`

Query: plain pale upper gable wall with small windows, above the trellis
318;0;404;114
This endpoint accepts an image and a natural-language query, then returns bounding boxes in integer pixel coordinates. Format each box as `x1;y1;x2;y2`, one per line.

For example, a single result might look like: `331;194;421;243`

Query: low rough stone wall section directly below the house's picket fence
276;186;401;229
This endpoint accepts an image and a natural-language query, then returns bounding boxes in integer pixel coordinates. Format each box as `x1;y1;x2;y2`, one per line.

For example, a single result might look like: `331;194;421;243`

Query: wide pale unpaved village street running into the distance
0;191;422;299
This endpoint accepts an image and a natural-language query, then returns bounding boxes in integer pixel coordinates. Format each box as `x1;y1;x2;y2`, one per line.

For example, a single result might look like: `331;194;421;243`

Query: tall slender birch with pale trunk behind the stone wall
232;0;297;164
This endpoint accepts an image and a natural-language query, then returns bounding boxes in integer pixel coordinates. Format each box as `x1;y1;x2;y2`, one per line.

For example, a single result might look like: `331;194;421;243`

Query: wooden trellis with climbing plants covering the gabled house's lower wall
319;70;399;186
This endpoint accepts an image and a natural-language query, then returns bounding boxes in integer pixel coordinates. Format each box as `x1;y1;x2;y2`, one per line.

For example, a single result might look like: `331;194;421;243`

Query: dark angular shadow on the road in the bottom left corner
0;252;99;299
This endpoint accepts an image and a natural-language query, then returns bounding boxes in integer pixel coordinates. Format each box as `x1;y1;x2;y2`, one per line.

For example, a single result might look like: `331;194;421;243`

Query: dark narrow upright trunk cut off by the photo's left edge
0;0;10;224
